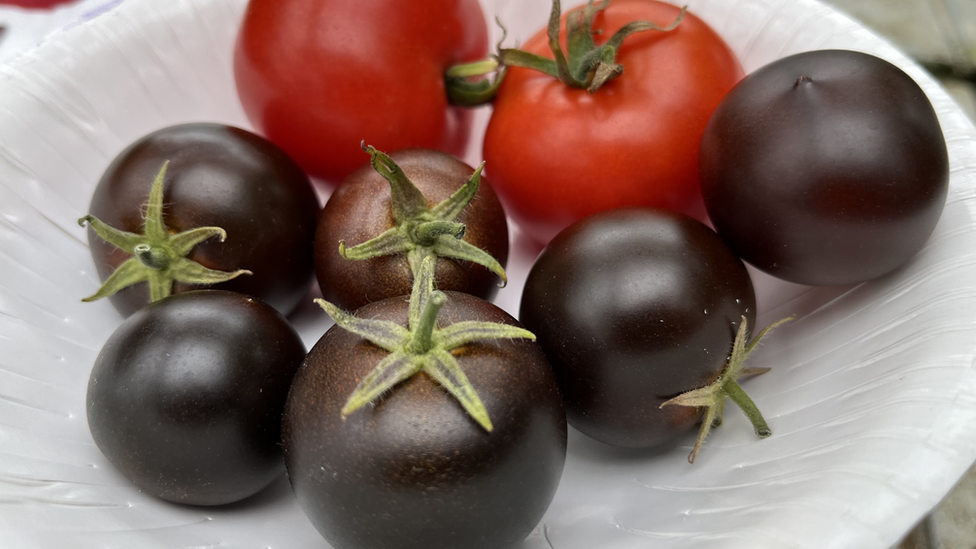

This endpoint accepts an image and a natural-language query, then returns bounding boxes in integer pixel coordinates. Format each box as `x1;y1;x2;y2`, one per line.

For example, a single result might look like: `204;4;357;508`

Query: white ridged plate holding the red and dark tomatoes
0;0;976;549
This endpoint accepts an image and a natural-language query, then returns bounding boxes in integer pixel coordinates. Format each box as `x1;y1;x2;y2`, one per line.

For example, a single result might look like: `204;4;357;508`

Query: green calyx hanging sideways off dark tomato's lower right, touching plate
661;316;793;463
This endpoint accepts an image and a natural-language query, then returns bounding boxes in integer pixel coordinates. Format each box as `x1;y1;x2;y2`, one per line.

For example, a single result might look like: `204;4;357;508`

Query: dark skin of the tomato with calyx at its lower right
519;209;756;448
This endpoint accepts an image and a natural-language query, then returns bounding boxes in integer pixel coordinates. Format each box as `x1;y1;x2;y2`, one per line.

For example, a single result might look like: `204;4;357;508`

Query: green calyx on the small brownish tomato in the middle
339;145;508;286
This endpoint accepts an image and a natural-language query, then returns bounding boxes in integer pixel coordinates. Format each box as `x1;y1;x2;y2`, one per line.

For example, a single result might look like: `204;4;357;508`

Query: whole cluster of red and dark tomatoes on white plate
82;0;948;549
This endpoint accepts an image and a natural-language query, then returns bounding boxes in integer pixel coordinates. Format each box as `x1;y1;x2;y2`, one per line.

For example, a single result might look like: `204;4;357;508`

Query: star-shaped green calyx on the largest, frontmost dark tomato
315;257;535;432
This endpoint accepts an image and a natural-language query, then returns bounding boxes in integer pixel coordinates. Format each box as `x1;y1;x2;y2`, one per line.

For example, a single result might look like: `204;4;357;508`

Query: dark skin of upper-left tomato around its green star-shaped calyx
88;123;320;316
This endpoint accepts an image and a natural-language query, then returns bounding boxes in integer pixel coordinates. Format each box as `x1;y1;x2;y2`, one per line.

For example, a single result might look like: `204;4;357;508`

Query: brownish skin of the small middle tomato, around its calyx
315;149;508;311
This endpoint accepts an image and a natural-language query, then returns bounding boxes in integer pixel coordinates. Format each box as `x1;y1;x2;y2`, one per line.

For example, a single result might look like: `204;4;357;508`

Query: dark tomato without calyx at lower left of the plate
87;290;305;505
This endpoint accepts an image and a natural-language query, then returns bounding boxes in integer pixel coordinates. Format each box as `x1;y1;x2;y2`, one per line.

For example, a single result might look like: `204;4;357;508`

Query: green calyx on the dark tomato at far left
78;161;252;302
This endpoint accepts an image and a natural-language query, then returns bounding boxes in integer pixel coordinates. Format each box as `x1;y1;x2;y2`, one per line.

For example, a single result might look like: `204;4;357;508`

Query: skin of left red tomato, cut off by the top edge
234;0;488;183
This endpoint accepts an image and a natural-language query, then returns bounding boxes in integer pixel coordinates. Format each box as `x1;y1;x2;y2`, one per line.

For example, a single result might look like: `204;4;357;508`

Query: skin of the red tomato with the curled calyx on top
484;0;743;243
